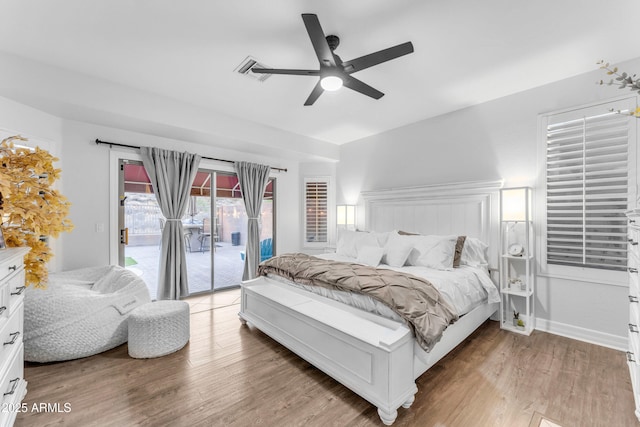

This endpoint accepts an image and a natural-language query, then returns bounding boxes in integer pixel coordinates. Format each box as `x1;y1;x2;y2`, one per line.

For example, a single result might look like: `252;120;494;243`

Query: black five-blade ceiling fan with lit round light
251;13;413;105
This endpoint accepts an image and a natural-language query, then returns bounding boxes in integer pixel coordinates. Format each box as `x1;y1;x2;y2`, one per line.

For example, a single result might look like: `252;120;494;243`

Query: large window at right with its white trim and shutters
536;96;639;286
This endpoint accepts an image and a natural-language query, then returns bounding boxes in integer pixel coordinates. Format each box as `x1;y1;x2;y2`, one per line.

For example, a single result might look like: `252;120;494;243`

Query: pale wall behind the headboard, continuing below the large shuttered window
337;59;640;349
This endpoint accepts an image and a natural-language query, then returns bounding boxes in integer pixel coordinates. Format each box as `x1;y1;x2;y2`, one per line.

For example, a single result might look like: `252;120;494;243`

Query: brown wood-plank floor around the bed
15;290;639;427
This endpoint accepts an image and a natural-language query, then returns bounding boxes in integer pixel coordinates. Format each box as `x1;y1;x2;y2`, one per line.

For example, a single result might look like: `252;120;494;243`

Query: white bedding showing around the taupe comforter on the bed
269;254;500;322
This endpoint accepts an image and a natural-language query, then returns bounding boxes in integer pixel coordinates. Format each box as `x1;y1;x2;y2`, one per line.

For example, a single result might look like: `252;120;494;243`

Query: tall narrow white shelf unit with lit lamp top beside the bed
500;187;535;335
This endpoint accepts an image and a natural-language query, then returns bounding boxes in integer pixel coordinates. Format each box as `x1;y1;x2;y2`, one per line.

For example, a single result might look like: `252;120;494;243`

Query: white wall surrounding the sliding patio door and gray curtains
56;120;300;270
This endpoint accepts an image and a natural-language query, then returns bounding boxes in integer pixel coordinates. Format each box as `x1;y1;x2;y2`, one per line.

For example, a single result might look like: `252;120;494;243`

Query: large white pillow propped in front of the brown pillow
408;235;458;270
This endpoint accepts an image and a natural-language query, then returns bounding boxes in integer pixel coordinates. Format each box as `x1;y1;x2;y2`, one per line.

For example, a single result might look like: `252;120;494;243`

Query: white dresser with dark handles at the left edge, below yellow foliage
0;248;29;427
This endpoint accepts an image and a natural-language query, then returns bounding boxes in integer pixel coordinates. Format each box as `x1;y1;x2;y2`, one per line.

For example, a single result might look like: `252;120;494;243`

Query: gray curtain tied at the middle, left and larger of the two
140;147;200;300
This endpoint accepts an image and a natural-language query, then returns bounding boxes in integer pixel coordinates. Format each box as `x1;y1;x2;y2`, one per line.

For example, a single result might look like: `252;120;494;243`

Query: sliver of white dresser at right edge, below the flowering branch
627;209;640;420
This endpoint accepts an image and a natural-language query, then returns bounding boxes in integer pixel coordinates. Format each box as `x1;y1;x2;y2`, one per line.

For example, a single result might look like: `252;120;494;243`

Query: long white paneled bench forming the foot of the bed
239;277;418;425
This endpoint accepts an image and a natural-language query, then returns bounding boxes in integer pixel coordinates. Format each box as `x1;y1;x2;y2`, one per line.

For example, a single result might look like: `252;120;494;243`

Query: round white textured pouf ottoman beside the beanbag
128;300;189;359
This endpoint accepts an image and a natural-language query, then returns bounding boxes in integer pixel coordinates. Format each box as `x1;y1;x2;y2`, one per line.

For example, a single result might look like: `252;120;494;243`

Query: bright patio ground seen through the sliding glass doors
125;242;244;299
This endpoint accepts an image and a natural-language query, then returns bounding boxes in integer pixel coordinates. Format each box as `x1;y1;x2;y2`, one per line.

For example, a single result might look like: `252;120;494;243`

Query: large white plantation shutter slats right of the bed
546;106;636;270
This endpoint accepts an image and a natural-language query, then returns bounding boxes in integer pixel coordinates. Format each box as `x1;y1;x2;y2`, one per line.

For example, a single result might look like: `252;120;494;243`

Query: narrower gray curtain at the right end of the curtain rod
234;162;271;280
